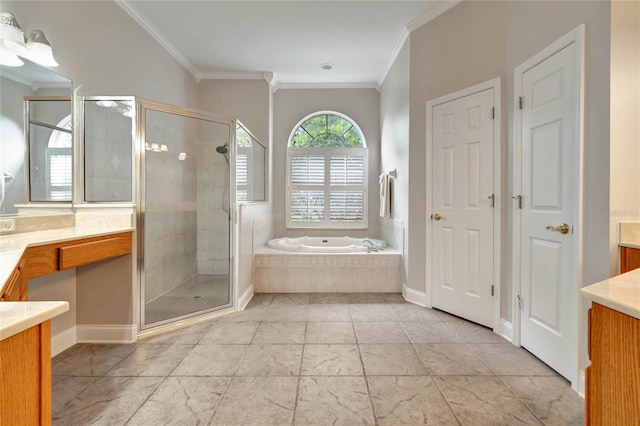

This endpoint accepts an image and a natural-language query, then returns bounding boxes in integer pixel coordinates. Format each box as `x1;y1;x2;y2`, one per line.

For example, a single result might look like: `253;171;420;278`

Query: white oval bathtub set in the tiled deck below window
267;237;387;253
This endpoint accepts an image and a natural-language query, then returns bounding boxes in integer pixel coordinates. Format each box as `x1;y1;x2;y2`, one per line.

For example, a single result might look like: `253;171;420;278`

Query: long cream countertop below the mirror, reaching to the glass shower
0;226;134;288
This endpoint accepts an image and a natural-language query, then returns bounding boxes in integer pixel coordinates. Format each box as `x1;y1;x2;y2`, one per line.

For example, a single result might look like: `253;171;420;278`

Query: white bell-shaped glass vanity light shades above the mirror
0;12;58;67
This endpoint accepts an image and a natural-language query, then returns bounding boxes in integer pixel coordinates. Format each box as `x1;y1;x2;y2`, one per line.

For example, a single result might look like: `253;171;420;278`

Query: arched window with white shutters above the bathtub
287;112;367;228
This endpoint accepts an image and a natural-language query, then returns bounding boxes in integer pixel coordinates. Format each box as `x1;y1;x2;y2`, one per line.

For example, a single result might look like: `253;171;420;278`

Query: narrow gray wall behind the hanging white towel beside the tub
380;41;411;284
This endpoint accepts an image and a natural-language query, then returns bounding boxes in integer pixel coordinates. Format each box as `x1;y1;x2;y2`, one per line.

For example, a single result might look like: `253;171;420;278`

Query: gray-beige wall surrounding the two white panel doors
392;1;610;321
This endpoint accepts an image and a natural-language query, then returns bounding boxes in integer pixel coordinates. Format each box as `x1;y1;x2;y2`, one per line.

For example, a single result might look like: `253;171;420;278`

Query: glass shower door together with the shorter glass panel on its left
83;96;236;330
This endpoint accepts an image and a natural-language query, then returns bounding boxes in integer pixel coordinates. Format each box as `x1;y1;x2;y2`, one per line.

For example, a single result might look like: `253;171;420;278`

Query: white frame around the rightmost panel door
512;24;585;389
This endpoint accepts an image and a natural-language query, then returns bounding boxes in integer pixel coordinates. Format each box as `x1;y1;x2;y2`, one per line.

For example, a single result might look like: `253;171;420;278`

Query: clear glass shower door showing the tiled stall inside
139;101;232;328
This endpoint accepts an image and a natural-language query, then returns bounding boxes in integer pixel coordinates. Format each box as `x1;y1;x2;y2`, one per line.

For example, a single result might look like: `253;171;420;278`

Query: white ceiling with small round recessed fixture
116;0;458;87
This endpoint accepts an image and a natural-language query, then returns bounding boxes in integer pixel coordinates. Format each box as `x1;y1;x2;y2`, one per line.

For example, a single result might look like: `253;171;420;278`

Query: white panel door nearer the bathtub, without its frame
431;89;494;327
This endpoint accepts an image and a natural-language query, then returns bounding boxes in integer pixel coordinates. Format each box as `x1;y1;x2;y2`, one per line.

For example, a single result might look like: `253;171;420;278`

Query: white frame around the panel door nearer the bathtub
425;77;503;334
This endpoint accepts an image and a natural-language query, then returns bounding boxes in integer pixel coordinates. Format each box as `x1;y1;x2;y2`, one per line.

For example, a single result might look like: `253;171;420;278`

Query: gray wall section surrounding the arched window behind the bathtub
272;89;380;238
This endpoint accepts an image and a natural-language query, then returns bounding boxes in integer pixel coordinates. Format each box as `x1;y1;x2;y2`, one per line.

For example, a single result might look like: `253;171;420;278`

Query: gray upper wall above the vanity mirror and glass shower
2;1;197;107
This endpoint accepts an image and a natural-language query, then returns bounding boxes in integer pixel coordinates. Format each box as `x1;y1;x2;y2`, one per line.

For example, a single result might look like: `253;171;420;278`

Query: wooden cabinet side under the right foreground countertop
585;303;640;426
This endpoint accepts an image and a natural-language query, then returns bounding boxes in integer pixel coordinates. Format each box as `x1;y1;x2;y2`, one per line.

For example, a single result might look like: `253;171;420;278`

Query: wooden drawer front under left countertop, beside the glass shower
59;236;131;270
